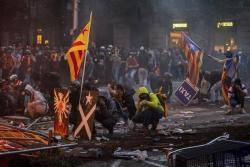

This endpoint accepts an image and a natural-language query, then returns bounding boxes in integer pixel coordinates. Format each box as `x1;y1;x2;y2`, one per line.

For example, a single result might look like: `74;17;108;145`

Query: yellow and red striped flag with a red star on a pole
66;12;92;81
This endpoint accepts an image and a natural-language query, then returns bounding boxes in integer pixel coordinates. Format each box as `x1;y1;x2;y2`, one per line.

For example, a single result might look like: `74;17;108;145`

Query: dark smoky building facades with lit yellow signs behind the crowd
0;0;250;53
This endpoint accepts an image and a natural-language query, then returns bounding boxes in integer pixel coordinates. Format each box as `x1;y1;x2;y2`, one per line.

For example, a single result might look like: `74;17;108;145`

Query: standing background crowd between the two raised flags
86;45;186;86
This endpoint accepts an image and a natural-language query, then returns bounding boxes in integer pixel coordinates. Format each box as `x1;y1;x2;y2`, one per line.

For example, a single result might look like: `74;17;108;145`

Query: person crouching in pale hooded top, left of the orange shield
24;84;49;118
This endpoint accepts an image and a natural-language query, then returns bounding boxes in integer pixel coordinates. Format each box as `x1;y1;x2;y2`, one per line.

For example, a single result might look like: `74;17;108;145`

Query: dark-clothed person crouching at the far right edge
226;79;247;114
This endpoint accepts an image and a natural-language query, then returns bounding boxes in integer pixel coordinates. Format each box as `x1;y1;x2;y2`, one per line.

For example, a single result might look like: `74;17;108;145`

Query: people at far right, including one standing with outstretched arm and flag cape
200;51;248;114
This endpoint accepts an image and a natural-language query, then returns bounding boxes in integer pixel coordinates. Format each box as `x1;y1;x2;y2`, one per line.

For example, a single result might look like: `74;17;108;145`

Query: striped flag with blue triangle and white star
181;32;203;86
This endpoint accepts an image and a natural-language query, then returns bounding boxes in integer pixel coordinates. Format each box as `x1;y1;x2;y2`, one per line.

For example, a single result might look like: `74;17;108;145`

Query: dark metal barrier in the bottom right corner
167;138;250;167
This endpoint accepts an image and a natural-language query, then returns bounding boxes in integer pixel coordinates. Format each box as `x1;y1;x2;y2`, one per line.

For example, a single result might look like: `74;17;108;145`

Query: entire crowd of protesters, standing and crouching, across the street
0;45;247;137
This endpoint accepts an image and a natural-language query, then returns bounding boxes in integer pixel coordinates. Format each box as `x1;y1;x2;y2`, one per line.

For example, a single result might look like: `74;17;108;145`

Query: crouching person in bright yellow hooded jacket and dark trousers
132;87;164;131
